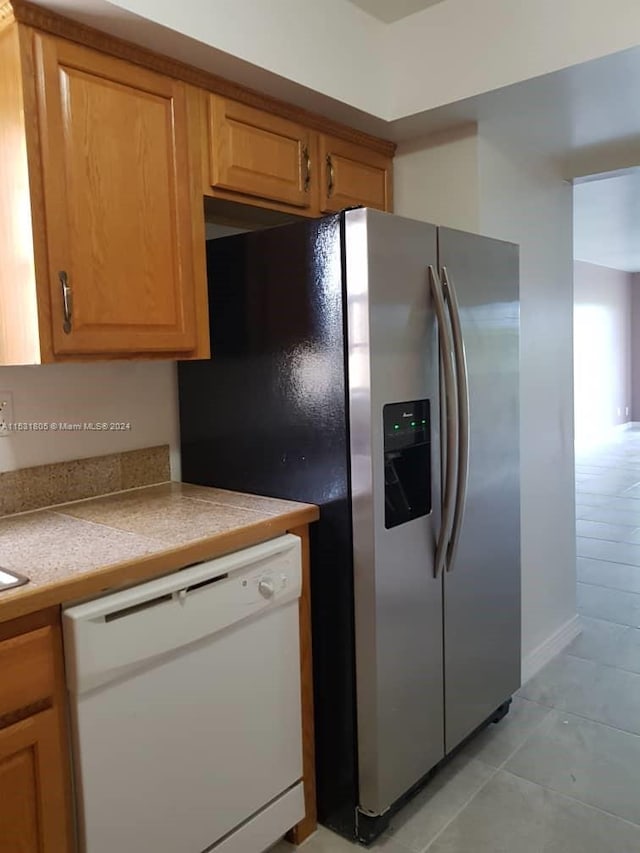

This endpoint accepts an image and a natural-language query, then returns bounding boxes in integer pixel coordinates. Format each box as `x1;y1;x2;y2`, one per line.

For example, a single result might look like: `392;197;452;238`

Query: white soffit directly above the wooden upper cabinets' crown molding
47;0;392;115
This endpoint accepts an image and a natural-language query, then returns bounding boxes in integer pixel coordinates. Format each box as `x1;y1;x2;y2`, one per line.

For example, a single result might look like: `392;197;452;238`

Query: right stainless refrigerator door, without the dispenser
438;228;520;752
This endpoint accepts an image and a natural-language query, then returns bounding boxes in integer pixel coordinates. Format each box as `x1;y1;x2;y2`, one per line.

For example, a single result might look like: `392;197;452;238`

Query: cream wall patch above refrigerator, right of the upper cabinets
393;124;480;231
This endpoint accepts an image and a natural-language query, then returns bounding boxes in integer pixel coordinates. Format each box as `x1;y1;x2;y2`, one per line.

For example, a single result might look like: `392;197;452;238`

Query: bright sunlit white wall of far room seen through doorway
574;261;632;448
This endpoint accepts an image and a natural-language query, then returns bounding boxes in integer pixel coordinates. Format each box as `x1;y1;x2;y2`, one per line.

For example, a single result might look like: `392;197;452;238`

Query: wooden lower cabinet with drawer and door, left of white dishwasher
0;610;74;853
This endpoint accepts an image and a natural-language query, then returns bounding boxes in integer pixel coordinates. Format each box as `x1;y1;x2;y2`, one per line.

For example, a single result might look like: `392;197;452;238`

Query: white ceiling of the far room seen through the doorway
573;174;640;272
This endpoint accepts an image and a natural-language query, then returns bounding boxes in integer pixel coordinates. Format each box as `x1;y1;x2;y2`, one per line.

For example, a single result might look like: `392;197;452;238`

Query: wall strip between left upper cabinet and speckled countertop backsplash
0;361;179;477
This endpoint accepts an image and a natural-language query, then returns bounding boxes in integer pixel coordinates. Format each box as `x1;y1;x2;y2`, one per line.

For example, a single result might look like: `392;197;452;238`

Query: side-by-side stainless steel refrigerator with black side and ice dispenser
179;209;520;842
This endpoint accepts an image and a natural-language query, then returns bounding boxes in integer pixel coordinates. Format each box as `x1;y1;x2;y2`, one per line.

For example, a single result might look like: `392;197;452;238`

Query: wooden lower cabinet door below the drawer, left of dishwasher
0;710;71;853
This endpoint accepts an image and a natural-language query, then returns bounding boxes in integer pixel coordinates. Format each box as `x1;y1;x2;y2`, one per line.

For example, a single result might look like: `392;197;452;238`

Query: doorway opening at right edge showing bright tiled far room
574;168;640;652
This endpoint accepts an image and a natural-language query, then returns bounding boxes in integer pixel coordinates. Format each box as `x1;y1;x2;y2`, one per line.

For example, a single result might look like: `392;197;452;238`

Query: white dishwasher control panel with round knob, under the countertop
62;534;302;693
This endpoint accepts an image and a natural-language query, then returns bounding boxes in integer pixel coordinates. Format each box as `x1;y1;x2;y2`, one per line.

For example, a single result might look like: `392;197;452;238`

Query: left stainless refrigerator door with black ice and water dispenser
345;210;444;816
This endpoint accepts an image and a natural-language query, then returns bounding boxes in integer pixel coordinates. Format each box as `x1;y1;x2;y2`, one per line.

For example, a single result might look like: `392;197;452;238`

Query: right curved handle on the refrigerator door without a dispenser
442;266;470;572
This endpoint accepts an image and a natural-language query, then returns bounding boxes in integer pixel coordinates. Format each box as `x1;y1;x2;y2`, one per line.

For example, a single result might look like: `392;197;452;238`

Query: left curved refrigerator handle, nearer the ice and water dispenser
429;265;459;578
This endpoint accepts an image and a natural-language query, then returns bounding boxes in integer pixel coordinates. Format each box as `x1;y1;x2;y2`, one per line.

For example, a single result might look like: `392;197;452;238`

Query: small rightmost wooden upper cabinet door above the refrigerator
320;134;392;213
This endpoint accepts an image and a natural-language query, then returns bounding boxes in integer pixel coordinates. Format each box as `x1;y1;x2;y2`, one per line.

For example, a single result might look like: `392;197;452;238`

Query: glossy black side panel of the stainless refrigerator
178;216;358;835
